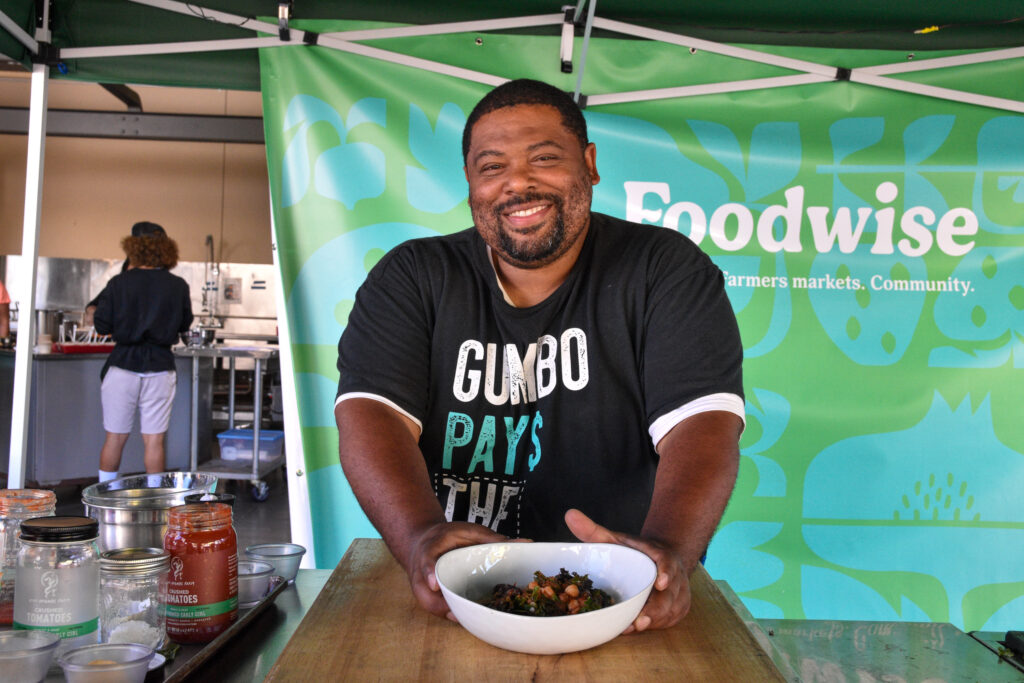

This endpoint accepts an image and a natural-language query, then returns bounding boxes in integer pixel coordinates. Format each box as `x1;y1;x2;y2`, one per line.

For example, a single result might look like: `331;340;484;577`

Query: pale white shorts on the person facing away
99;366;178;434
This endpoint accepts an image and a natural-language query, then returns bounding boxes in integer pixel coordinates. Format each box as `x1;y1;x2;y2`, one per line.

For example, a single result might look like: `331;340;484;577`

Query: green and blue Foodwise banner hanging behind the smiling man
261;23;1024;631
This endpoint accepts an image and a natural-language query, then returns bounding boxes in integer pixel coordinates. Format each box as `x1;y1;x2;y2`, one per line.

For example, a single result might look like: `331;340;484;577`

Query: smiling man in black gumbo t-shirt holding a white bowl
335;80;743;630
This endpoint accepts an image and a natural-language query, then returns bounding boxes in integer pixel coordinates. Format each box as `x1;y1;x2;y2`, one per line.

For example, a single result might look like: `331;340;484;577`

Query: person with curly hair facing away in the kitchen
93;221;193;481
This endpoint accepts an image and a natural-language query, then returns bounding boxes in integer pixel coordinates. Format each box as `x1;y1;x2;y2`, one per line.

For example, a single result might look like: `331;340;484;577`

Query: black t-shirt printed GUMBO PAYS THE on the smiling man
338;213;742;541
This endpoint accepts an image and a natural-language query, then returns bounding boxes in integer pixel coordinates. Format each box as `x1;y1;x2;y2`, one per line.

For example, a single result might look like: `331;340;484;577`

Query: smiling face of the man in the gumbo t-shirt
466;104;600;268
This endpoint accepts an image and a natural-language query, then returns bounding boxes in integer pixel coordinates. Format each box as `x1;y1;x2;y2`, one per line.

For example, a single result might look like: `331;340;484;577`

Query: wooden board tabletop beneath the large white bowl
266;539;785;683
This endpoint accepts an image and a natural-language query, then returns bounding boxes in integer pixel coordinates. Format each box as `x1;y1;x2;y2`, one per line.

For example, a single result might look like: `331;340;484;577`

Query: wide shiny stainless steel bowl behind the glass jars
82;472;217;551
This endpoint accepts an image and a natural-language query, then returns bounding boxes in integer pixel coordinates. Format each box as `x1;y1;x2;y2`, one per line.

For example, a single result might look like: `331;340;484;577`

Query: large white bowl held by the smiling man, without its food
434;543;657;654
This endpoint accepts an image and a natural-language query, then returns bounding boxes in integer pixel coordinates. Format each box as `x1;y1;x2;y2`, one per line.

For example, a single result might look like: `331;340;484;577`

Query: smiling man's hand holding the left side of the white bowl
406;522;507;622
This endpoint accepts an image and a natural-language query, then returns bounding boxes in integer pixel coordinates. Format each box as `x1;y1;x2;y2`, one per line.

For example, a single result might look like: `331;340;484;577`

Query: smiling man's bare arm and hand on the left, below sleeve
334;398;505;617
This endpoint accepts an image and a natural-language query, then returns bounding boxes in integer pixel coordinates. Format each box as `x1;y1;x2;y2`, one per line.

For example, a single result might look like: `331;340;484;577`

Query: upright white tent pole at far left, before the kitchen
7;3;50;488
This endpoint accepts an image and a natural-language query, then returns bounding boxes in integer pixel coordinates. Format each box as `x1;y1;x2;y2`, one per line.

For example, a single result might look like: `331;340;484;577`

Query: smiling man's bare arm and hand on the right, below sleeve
565;411;742;631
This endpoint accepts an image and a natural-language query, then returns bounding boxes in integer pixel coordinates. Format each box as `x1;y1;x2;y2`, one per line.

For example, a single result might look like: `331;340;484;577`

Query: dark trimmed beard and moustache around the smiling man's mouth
470;182;591;268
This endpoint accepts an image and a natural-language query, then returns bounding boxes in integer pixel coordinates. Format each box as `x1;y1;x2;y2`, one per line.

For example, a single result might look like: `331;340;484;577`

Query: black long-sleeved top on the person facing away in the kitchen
93;268;193;374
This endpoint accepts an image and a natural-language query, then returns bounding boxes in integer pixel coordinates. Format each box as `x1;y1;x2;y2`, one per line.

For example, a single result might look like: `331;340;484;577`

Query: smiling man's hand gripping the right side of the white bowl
565;510;690;633
